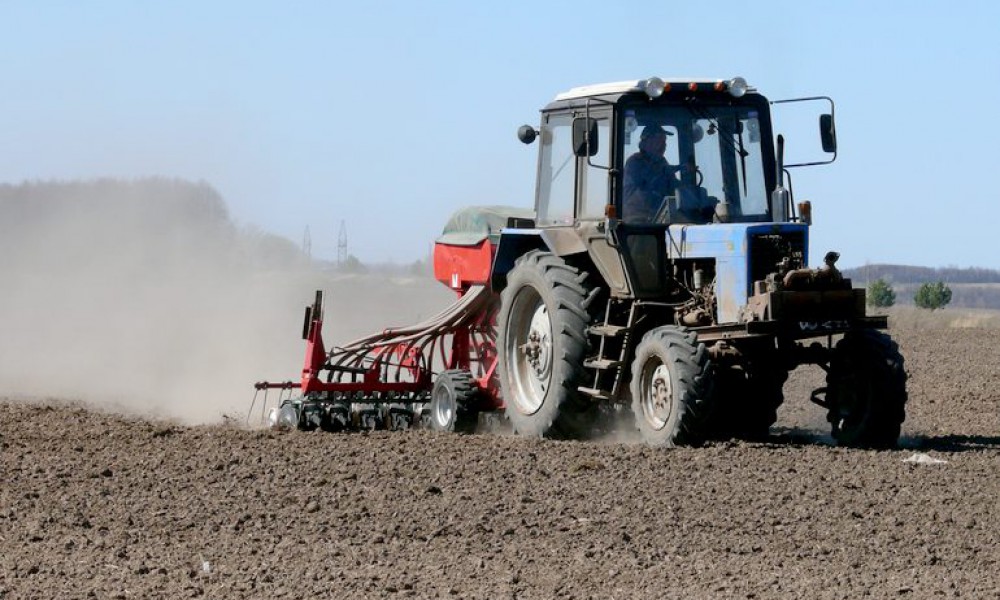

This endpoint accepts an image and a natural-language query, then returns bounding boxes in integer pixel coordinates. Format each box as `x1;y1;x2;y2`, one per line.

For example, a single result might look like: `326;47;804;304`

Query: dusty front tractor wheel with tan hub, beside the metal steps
630;325;713;447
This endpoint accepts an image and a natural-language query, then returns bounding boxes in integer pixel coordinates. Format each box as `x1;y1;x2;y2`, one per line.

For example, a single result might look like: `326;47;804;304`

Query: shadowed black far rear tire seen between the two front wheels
707;364;788;441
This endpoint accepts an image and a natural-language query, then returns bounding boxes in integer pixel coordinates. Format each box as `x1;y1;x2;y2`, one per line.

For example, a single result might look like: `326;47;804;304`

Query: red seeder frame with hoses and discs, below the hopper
248;285;502;431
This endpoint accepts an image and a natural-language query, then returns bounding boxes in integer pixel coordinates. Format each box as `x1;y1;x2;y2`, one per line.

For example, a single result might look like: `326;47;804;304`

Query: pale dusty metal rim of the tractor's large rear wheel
504;288;552;415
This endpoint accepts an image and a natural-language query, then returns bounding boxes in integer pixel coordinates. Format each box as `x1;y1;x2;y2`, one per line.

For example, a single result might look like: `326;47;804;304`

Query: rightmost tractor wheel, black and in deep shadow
826;331;907;448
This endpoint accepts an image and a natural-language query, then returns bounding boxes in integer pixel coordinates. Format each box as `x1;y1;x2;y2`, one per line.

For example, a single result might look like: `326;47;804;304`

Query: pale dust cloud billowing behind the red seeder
0;179;451;423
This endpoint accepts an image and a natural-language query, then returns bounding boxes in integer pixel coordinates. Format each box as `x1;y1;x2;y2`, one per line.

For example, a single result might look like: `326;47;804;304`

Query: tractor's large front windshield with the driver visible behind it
621;104;768;223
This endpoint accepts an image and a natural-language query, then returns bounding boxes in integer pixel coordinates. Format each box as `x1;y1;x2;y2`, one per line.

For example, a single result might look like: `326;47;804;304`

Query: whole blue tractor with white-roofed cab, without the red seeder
489;77;907;448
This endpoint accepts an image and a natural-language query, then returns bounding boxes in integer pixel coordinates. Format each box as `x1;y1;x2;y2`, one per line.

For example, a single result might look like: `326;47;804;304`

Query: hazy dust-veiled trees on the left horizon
0;177;308;276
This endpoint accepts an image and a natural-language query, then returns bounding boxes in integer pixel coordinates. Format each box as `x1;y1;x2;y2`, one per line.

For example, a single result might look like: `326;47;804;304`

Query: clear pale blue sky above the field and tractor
0;0;1000;268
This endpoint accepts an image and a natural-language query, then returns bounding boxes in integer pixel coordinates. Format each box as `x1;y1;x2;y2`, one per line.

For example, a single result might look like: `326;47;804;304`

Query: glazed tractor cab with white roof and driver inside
522;78;788;225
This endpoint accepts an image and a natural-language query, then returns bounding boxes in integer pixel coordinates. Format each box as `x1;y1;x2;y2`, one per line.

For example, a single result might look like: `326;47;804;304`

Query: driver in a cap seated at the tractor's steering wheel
622;125;679;221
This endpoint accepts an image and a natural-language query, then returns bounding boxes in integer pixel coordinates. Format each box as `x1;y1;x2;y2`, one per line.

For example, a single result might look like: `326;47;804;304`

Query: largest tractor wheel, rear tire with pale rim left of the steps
497;250;597;438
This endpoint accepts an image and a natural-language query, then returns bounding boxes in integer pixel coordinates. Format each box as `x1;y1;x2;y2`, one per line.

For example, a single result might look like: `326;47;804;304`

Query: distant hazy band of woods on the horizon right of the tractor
844;265;1000;310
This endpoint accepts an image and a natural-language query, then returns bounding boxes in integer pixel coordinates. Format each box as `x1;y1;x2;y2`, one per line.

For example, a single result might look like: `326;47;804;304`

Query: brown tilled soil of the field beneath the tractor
0;329;1000;599
